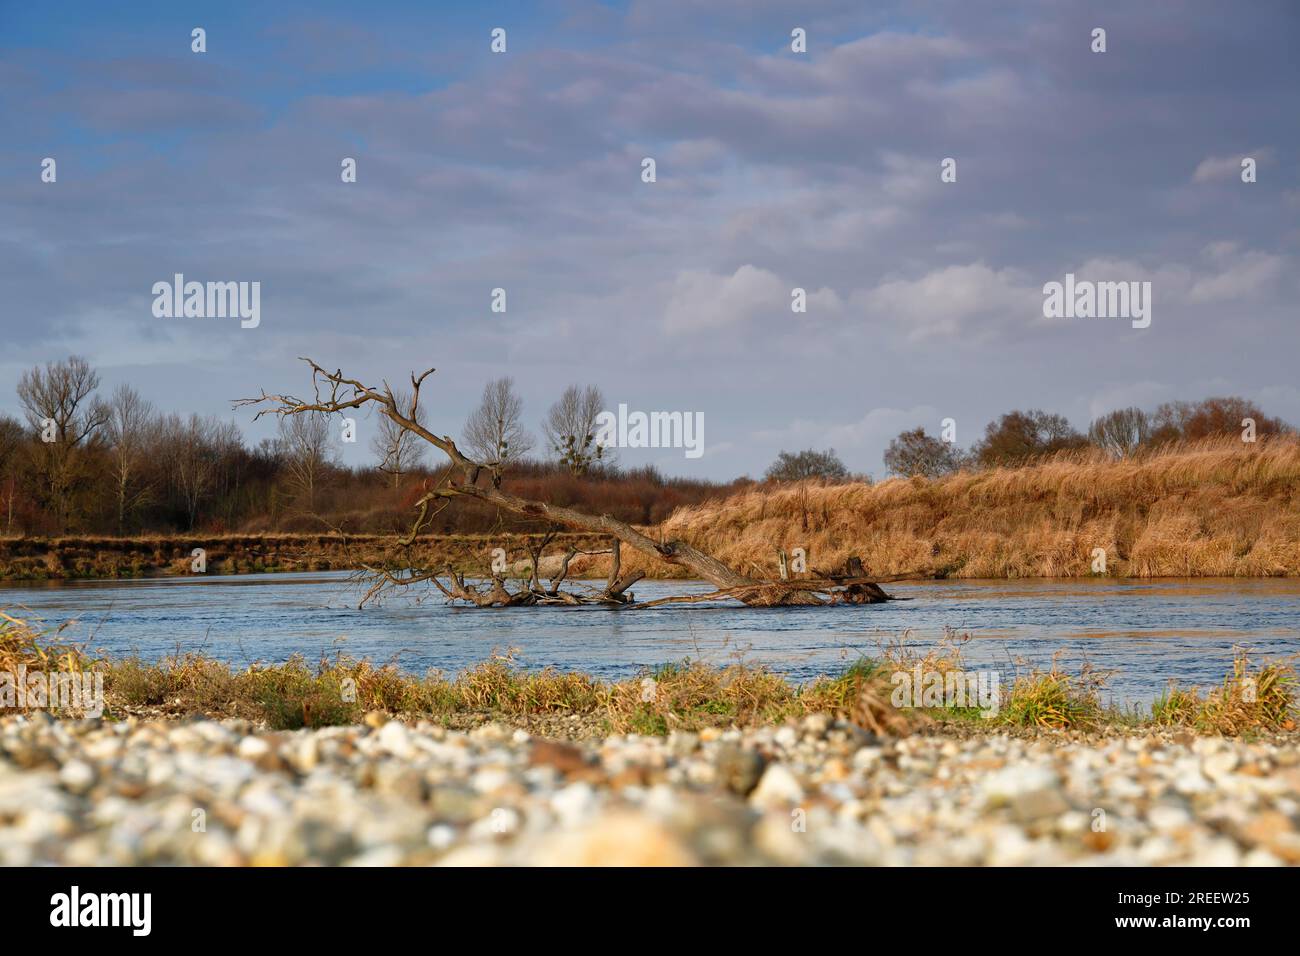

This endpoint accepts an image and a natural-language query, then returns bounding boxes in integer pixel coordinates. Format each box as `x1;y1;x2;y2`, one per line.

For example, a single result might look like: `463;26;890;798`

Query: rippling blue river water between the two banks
0;572;1300;705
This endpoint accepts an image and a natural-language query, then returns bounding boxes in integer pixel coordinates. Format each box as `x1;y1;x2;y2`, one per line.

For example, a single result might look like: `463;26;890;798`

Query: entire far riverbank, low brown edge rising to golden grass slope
0;436;1300;580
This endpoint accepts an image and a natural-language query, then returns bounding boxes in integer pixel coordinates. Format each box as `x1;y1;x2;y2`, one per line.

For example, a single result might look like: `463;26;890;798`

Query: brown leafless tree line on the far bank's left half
0;355;729;536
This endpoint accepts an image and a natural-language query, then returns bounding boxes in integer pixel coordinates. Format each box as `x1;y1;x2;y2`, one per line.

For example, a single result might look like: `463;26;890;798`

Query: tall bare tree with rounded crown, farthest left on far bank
18;355;108;528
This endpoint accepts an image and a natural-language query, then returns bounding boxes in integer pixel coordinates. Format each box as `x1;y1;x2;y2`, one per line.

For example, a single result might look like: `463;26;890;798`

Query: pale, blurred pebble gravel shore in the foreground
0;713;1300;866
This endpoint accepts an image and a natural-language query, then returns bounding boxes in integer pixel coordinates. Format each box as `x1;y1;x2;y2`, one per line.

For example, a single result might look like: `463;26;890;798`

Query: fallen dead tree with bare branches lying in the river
235;359;915;607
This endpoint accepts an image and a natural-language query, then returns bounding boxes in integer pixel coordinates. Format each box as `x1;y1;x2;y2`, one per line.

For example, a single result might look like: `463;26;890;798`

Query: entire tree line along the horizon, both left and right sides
0;356;1292;535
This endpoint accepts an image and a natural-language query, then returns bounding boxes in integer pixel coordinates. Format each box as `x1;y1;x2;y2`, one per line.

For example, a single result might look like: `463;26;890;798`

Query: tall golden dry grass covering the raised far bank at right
575;436;1300;578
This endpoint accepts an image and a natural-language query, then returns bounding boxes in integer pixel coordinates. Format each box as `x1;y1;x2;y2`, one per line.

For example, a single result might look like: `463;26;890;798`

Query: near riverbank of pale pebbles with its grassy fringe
0;617;1300;866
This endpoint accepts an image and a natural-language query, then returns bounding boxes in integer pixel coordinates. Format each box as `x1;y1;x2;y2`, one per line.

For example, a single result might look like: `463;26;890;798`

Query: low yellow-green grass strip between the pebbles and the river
0;613;1296;736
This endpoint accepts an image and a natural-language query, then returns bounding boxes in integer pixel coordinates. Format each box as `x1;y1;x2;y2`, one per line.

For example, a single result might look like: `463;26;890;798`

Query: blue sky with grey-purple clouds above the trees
0;0;1300;479
